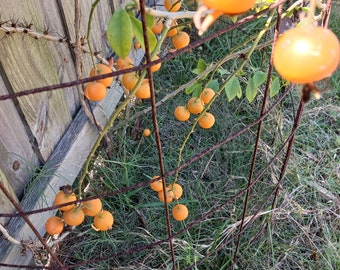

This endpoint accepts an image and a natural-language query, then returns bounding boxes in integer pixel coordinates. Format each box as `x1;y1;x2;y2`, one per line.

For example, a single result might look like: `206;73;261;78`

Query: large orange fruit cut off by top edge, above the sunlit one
202;0;256;15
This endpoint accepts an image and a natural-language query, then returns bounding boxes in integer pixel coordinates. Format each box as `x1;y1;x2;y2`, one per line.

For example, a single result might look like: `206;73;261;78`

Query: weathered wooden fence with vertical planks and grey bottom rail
0;0;138;265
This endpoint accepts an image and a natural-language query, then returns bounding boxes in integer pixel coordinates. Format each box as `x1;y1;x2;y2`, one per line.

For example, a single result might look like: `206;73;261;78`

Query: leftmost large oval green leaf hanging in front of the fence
106;9;132;58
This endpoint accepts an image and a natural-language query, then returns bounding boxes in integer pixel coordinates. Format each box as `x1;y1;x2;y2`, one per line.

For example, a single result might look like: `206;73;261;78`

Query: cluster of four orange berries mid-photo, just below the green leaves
174;88;215;129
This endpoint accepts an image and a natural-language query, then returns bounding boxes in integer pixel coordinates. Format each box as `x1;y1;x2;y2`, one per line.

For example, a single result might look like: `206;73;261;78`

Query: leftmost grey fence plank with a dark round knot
0;74;38;224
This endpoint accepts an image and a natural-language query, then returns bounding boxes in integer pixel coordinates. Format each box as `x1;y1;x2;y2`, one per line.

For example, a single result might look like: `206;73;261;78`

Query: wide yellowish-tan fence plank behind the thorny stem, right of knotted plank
0;0;74;160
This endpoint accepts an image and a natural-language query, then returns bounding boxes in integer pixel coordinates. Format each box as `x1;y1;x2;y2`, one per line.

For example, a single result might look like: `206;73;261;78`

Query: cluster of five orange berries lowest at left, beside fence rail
45;186;114;235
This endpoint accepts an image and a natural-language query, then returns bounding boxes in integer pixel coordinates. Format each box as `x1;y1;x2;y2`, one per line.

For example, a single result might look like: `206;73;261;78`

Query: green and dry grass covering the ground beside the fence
59;3;340;269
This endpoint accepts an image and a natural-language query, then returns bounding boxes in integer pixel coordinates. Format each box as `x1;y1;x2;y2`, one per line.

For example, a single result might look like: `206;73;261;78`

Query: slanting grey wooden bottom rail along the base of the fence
0;84;124;264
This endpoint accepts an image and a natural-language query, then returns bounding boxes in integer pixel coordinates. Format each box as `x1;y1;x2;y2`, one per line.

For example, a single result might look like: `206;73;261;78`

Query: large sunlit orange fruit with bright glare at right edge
273;26;340;84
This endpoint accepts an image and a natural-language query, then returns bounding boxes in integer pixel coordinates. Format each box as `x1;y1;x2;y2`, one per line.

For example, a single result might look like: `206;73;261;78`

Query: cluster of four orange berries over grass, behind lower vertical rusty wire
150;176;189;221
